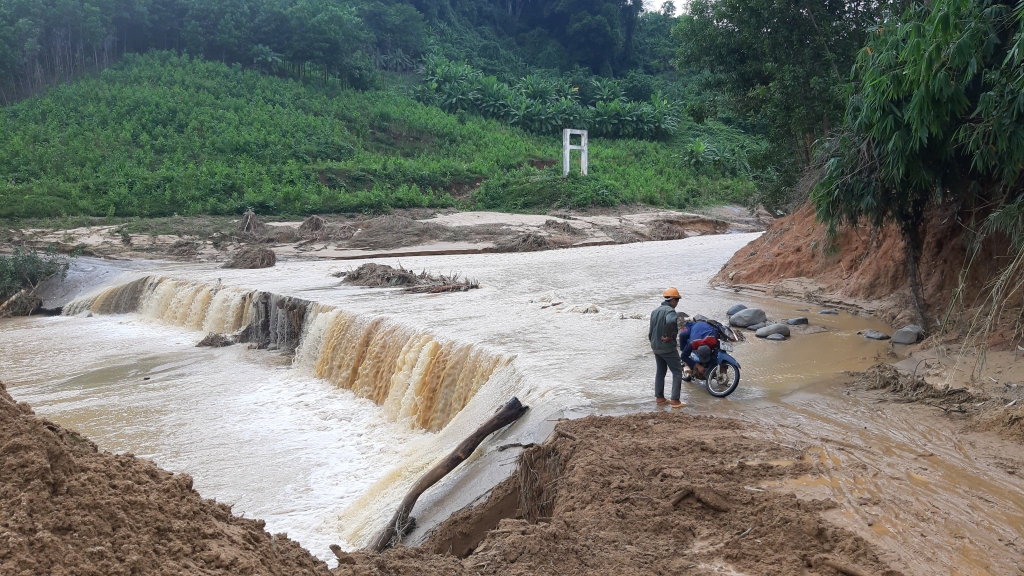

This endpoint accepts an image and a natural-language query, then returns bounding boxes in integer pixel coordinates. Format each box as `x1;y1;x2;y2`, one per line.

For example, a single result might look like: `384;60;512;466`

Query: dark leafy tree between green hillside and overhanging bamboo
673;0;889;208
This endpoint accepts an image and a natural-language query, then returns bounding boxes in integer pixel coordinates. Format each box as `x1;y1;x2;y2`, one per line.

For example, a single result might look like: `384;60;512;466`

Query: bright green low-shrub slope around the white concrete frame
0;52;757;217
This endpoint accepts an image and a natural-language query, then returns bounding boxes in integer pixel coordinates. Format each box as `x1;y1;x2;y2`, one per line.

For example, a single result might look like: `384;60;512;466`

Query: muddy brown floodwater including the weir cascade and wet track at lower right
0;235;1024;574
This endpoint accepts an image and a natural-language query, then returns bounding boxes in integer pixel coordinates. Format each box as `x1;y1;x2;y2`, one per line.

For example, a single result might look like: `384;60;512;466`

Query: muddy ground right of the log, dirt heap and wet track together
335;349;1024;576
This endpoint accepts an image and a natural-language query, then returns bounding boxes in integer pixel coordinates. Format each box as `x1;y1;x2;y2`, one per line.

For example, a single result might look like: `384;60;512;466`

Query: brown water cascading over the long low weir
63;276;511;431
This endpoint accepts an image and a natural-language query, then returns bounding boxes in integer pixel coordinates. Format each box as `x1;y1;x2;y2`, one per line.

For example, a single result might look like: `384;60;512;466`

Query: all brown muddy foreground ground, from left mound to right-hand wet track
0;342;1024;576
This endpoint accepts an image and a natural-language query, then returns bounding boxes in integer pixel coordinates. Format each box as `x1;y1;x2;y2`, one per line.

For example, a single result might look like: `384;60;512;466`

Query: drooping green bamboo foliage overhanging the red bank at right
814;0;1024;325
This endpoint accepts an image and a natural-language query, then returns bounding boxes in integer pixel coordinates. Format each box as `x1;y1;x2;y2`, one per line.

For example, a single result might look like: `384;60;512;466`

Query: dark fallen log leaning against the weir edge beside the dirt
367;398;528;552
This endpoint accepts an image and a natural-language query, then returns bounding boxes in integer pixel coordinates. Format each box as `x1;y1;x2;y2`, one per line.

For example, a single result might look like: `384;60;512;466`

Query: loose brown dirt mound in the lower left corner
0;383;330;576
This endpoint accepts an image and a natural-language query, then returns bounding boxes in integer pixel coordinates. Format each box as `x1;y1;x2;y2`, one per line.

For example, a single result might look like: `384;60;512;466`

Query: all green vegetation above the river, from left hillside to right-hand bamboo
6;0;1024;268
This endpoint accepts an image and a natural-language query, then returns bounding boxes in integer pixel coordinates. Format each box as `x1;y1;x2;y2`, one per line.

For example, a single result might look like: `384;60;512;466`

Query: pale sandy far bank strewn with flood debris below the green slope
0;206;771;261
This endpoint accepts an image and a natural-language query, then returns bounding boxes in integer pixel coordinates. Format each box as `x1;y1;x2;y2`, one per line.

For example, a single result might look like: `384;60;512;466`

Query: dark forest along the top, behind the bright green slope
0;0;669;101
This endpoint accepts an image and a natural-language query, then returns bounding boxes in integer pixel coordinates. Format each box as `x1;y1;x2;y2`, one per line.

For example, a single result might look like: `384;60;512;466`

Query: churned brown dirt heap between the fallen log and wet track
335;411;899;576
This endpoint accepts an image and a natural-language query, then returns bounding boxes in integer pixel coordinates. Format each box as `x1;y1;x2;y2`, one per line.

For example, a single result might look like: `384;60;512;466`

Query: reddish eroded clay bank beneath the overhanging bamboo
712;203;1006;325
